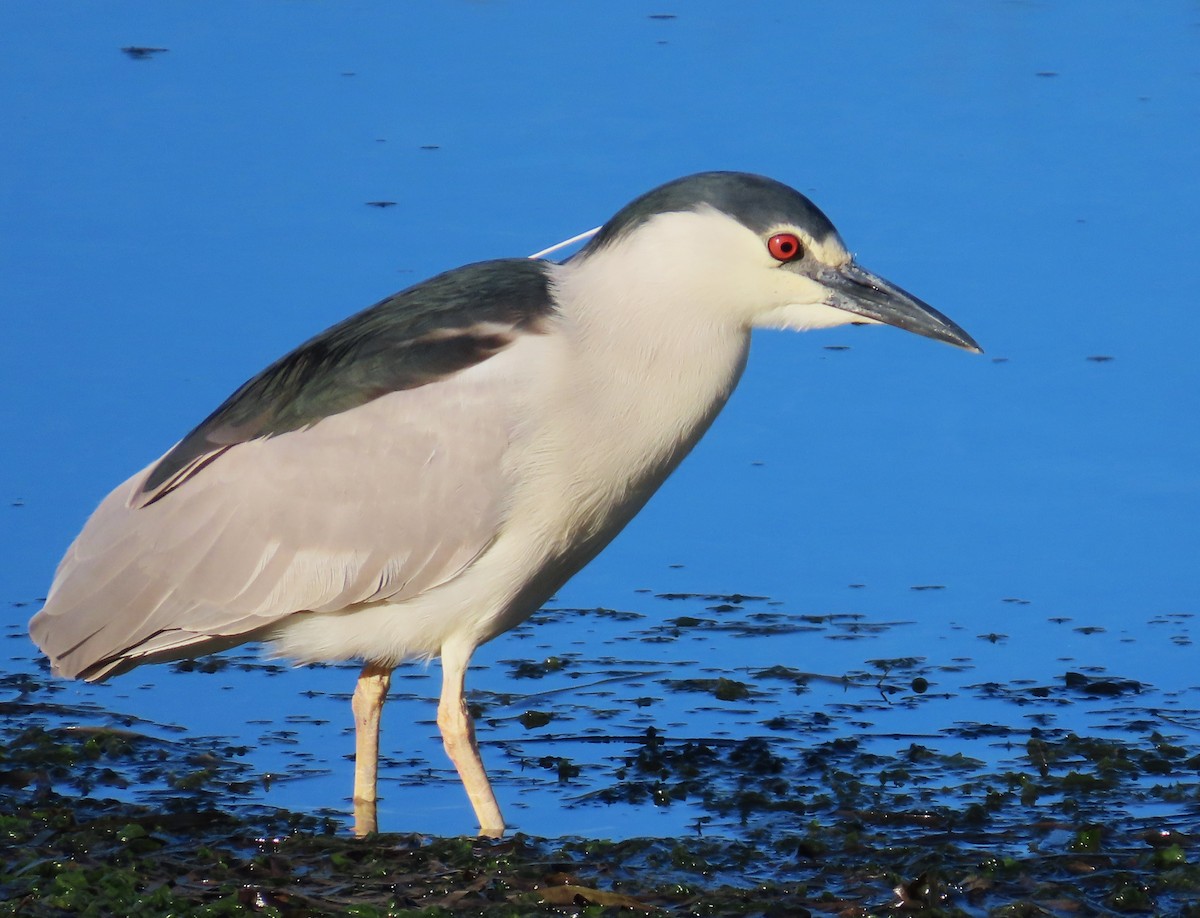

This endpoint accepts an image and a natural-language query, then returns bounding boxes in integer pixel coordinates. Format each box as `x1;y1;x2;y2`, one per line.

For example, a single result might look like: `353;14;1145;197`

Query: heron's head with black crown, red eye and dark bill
572;172;979;350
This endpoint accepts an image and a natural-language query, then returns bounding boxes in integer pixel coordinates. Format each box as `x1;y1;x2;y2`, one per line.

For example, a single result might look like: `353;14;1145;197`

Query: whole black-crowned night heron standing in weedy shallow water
30;173;978;835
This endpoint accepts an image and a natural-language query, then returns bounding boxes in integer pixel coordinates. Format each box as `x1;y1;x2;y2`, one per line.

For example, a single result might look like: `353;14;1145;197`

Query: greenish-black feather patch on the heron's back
140;259;553;506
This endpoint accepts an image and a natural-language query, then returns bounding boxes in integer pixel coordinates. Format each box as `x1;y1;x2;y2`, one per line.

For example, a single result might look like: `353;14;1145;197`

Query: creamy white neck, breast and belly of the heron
277;225;749;660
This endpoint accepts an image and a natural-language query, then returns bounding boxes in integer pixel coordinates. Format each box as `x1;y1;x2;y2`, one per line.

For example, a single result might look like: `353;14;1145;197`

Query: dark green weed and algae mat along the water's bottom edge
0;673;1200;918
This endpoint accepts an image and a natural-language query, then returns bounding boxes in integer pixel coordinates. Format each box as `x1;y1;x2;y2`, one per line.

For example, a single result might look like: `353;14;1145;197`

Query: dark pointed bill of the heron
817;262;983;354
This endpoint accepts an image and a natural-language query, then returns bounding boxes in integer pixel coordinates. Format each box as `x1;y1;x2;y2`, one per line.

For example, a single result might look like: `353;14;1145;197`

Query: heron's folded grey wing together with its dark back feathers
30;258;548;678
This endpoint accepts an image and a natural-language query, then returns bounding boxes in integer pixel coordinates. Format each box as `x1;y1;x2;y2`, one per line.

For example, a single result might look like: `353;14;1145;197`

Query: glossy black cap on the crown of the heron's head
576;172;838;258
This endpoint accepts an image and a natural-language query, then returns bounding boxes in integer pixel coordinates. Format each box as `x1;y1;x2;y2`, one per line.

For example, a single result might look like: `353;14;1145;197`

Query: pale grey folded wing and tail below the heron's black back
30;336;536;678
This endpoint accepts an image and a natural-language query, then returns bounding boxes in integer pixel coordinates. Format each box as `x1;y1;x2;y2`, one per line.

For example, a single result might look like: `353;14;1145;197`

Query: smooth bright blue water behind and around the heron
0;0;1200;835
